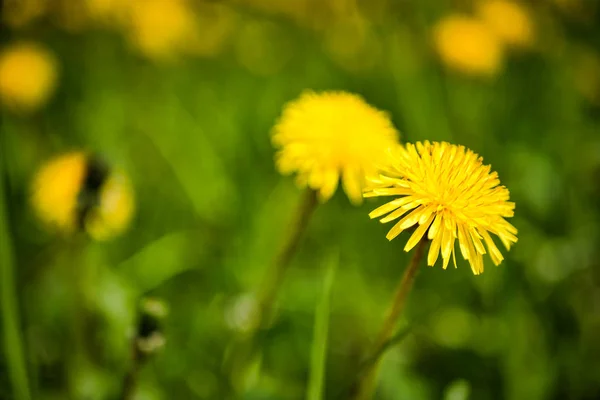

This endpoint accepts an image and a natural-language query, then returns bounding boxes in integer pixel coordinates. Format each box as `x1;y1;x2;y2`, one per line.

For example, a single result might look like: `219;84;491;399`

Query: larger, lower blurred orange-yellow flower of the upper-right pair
433;14;504;76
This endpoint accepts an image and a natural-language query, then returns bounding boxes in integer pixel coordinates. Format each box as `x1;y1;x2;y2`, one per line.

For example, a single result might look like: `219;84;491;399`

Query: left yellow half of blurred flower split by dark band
31;152;87;233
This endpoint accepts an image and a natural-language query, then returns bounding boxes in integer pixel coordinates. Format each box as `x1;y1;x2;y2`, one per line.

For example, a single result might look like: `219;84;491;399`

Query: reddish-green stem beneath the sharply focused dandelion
355;237;427;400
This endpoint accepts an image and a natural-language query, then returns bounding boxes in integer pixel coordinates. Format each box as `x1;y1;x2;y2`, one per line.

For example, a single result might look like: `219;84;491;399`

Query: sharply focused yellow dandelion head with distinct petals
365;141;517;274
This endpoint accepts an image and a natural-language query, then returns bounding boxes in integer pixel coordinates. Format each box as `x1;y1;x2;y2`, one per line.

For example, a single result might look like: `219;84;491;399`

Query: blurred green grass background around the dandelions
0;0;600;400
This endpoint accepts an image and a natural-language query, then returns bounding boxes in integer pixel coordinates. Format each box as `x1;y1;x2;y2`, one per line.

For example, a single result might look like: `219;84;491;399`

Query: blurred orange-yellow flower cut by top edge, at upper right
477;0;535;48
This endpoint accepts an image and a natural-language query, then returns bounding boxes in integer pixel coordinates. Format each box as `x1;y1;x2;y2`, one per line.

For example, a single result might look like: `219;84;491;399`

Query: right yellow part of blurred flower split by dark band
85;171;135;240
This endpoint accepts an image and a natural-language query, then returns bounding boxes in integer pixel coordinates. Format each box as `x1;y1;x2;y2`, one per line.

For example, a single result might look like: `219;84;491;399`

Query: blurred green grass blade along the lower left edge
0;152;31;400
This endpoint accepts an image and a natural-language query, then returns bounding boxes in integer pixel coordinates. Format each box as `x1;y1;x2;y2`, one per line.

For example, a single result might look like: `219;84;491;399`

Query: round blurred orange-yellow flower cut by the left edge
0;42;58;112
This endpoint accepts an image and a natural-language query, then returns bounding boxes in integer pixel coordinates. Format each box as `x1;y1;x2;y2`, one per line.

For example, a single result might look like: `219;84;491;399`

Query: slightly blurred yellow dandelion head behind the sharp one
273;91;398;204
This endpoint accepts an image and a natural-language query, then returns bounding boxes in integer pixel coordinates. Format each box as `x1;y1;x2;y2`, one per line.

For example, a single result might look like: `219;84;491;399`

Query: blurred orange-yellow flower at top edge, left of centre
130;0;198;60
